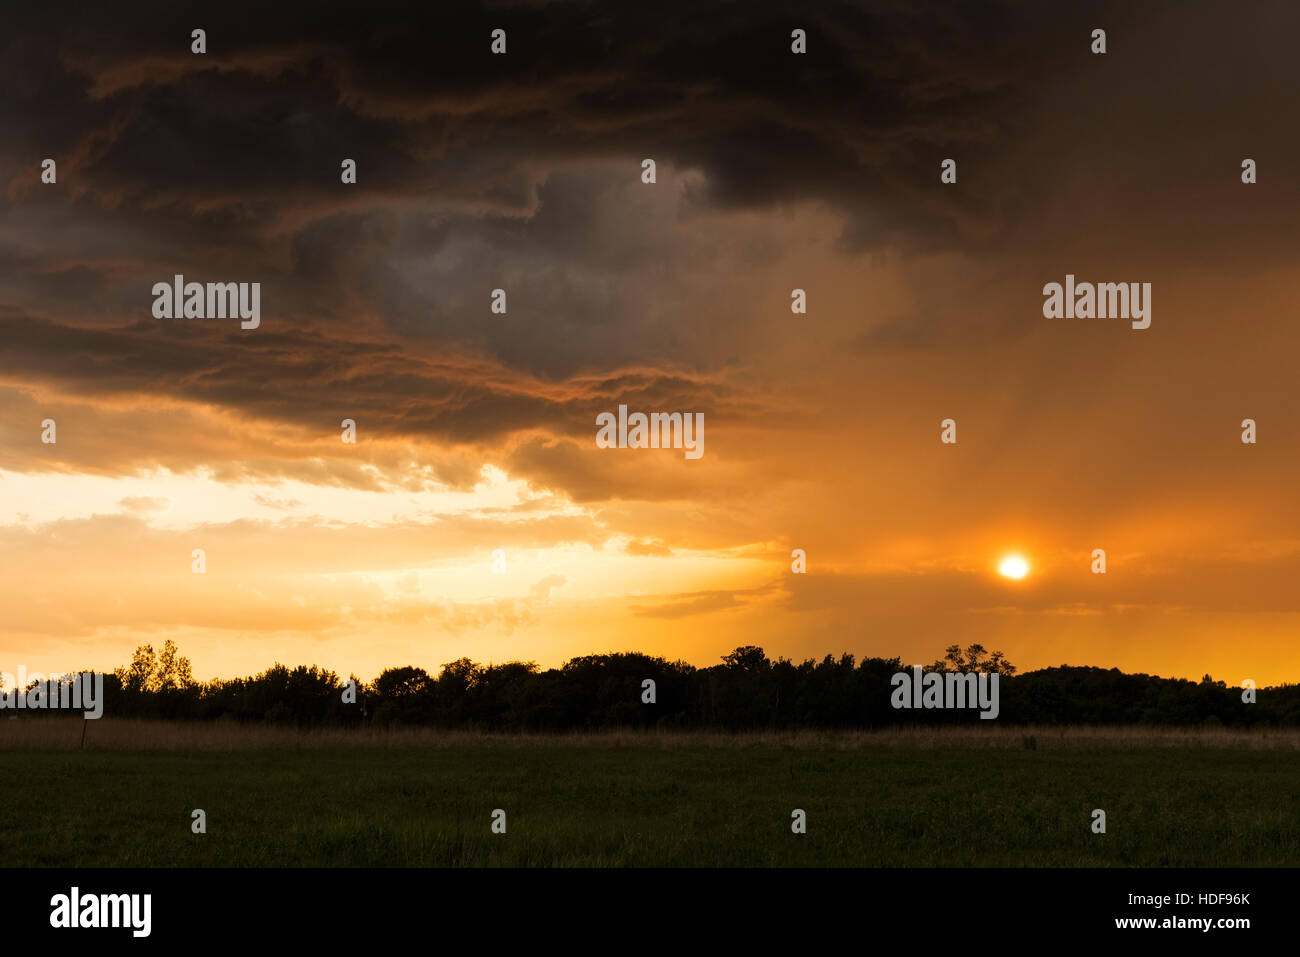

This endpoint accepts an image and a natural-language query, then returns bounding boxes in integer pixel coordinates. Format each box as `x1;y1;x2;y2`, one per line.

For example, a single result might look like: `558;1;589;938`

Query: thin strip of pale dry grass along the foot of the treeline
0;718;1300;750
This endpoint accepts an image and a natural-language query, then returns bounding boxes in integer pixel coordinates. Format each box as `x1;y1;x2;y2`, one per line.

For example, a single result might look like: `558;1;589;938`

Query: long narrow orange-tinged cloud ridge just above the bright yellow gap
0;308;748;455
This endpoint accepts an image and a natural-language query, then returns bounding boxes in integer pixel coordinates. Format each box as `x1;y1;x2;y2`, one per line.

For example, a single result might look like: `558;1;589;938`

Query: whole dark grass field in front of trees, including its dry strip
0;720;1300;866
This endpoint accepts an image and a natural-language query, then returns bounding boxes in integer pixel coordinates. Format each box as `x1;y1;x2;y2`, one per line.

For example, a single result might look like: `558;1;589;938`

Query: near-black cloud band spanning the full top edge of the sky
0;3;1300;261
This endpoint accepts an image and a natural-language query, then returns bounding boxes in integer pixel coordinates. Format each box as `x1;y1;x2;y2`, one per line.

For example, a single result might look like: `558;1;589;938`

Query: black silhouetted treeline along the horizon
27;641;1300;731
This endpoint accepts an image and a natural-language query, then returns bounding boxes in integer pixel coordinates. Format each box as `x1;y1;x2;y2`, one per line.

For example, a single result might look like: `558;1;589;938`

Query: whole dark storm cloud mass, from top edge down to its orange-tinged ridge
0;3;1300;481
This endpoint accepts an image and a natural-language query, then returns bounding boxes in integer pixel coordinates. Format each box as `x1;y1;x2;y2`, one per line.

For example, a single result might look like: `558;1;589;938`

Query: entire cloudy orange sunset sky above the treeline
0;1;1300;684
